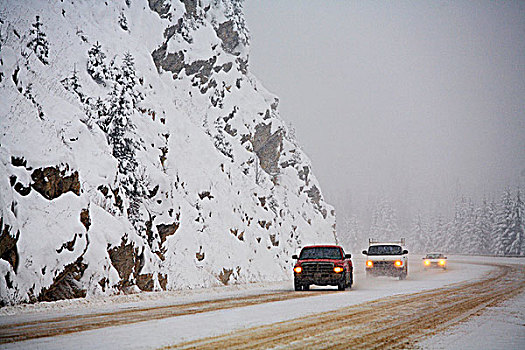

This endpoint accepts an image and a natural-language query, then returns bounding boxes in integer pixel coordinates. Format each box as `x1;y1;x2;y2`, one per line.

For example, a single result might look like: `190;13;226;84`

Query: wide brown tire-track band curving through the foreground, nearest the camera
162;263;525;349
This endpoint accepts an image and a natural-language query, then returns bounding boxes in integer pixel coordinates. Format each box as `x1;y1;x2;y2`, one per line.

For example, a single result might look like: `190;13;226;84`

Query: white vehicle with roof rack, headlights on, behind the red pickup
363;238;408;280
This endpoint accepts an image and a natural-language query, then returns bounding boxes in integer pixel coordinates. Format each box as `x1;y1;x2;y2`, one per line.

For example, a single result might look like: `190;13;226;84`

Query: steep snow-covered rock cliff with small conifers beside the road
0;0;335;304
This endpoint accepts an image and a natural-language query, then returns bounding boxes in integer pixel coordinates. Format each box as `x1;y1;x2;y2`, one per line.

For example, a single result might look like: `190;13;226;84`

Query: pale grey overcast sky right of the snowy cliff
244;0;525;219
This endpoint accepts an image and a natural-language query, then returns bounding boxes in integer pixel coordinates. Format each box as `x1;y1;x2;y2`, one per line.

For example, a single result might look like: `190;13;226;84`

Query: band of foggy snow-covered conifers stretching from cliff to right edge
339;189;525;256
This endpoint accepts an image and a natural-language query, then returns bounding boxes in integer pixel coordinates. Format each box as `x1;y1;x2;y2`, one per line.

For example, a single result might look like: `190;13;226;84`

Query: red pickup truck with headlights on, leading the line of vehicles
292;245;353;290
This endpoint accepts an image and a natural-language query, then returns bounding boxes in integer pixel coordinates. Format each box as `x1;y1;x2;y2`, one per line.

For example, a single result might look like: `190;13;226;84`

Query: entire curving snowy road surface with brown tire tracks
0;256;525;349
